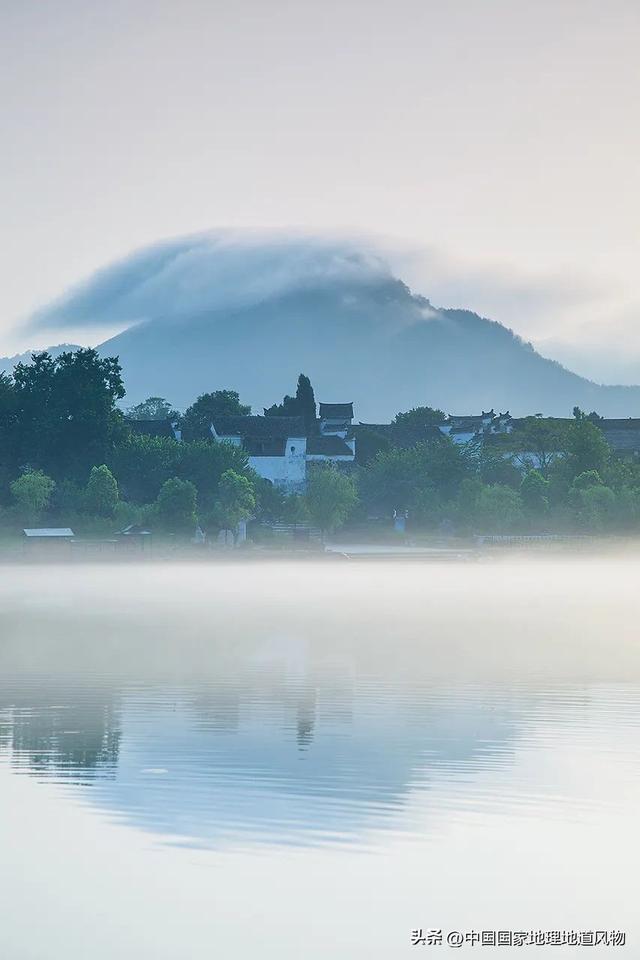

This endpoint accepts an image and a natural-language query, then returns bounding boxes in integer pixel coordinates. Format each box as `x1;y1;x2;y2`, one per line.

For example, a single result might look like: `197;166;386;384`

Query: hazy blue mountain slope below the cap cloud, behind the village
92;281;640;421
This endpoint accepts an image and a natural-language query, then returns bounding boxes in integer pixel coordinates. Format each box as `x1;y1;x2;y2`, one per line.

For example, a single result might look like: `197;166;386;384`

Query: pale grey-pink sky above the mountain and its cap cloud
0;0;640;383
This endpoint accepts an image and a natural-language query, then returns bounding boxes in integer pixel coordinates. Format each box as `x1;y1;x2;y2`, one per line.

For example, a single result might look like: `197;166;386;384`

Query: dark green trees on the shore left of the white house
0;349;350;534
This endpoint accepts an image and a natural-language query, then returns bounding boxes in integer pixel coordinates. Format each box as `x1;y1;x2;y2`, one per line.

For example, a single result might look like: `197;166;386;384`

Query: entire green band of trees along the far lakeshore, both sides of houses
0;350;640;535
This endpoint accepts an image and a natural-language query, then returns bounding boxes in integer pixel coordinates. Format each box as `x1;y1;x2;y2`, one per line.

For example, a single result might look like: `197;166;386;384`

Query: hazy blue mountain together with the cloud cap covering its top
18;231;640;421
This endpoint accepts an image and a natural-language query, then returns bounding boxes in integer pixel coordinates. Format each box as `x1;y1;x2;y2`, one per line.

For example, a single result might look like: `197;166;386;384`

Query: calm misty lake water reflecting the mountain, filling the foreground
0;559;640;960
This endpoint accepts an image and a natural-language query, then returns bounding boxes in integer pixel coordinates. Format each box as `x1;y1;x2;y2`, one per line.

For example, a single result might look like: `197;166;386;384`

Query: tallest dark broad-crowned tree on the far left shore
13;349;124;479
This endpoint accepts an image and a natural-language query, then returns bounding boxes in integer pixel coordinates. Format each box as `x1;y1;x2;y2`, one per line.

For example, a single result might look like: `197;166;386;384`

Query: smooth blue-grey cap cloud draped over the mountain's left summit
29;231;390;331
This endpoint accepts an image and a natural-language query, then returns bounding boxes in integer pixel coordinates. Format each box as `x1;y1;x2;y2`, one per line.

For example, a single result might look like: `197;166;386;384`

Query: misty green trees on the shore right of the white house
359;407;640;535
